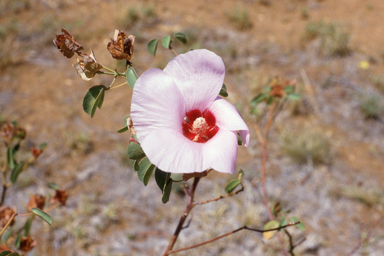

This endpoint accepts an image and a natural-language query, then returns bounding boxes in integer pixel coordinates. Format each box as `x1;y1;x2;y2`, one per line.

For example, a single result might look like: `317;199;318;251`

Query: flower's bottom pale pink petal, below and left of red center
140;130;206;173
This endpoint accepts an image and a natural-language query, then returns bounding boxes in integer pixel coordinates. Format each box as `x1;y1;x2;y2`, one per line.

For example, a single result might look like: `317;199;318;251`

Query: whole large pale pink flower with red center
131;50;249;174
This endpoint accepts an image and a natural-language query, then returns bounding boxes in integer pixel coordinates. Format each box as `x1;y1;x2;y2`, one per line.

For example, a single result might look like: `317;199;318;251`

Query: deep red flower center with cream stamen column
182;109;219;143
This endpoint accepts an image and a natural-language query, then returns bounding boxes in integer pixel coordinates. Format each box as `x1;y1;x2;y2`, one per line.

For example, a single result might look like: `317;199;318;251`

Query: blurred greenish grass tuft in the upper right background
303;21;351;57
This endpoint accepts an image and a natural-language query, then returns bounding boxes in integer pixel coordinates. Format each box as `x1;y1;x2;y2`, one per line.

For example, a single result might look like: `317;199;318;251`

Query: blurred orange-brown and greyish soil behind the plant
0;0;384;256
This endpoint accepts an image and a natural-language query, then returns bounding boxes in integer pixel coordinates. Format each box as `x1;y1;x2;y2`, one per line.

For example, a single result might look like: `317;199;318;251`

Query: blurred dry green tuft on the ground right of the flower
280;130;331;164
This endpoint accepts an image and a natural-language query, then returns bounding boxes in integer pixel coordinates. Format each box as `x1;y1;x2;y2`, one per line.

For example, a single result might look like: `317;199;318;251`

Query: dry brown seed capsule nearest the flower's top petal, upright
107;29;135;60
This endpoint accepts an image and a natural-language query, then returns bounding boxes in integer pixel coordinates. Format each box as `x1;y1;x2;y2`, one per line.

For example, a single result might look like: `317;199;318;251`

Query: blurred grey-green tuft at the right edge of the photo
358;92;384;119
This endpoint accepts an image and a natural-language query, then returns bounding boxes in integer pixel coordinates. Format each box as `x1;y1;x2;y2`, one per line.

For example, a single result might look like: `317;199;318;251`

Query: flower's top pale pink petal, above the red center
164;49;225;112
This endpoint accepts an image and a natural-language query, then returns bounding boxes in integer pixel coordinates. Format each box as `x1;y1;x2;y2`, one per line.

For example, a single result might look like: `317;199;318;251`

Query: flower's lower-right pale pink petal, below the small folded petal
203;129;238;174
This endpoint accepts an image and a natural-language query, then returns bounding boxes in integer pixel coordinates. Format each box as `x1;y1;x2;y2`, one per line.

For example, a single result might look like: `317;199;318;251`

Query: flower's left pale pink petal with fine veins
131;69;185;141
